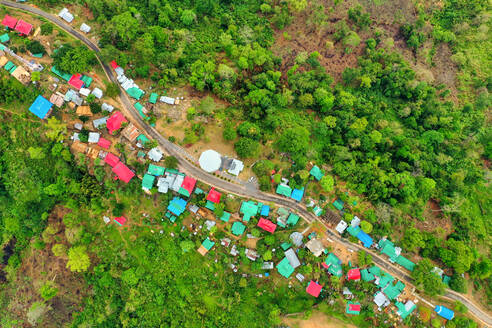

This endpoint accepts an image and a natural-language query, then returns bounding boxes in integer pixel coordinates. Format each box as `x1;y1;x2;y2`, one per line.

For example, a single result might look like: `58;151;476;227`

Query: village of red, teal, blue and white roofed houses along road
0;8;462;325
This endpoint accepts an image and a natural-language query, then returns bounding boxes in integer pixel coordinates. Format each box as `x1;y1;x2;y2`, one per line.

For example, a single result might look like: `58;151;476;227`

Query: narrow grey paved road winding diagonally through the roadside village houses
0;0;492;327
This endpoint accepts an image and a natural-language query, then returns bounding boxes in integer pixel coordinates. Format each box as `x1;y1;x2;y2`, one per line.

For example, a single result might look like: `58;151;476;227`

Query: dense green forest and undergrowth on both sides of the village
0;0;492;327
